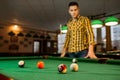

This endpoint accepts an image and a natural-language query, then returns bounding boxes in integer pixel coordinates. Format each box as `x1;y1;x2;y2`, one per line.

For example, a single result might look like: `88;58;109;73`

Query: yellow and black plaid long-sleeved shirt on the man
64;16;95;52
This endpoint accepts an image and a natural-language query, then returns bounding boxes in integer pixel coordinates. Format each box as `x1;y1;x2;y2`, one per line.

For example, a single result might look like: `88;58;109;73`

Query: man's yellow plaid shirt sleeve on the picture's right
85;17;95;45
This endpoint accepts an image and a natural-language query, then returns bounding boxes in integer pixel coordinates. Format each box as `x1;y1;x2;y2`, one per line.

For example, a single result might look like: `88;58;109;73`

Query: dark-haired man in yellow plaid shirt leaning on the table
61;2;97;58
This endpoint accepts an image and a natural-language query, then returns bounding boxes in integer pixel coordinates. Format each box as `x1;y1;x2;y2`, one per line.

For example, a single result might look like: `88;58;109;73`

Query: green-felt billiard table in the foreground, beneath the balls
0;56;120;80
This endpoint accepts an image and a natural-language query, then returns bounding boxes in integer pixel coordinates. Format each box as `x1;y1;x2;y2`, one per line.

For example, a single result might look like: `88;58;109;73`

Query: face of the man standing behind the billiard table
69;5;79;18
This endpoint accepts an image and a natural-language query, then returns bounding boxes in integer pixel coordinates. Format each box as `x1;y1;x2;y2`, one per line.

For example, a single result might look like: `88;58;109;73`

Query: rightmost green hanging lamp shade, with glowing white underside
105;16;119;26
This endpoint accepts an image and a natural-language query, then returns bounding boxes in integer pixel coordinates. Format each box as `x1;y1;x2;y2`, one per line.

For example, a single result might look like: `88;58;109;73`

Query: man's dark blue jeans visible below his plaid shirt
68;49;88;58
